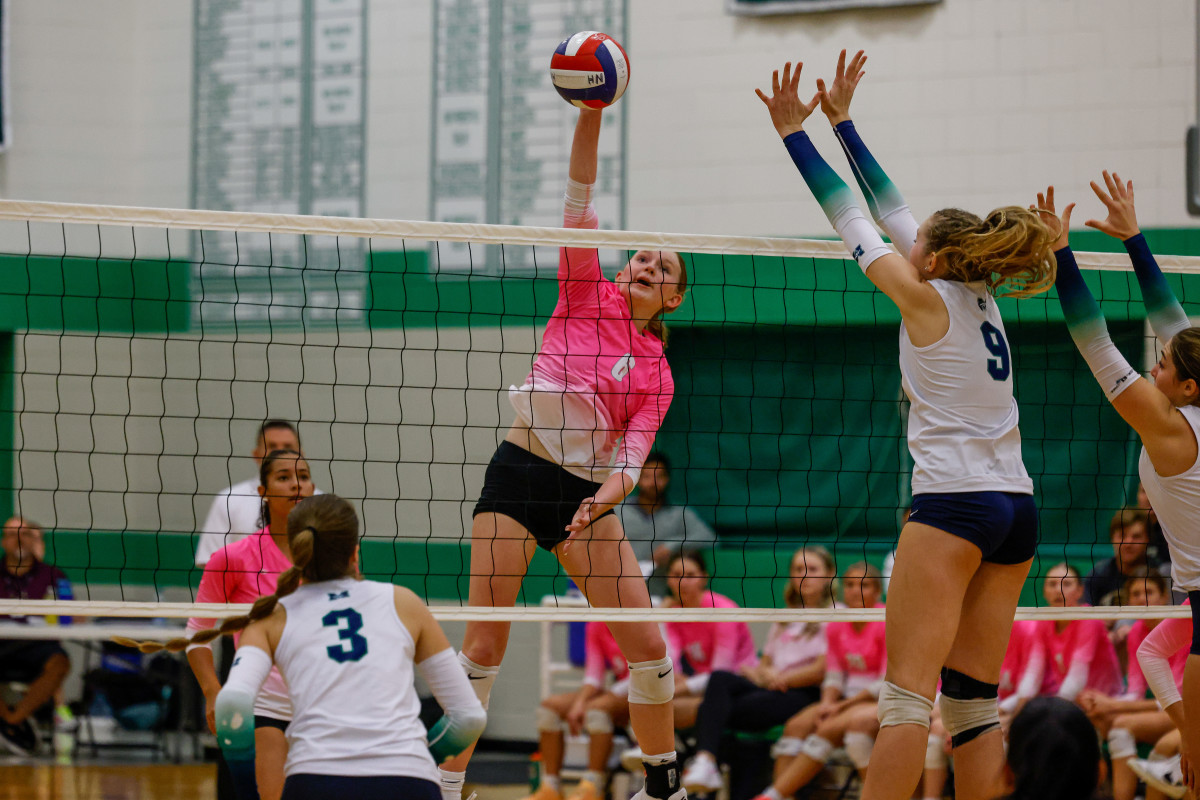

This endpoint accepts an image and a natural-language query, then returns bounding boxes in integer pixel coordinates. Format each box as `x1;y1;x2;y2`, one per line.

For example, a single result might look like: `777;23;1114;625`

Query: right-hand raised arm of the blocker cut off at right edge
1084;169;1192;342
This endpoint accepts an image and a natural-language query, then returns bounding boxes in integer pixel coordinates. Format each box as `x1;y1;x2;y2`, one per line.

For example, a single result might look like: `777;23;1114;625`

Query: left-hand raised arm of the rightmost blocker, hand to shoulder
1037;186;1195;475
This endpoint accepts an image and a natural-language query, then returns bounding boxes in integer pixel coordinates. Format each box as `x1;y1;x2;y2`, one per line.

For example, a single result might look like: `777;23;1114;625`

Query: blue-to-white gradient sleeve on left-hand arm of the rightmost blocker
1055;247;1139;402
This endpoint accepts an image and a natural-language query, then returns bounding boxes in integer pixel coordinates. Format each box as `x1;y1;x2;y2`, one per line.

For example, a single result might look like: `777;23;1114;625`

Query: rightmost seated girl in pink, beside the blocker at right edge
1079;575;1188;800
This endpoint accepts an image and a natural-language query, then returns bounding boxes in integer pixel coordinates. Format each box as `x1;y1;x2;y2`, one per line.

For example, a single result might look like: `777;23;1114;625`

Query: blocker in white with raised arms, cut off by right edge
1038;172;1200;792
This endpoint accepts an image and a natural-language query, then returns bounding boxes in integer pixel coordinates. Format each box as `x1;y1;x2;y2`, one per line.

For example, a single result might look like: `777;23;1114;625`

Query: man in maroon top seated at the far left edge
0;517;71;756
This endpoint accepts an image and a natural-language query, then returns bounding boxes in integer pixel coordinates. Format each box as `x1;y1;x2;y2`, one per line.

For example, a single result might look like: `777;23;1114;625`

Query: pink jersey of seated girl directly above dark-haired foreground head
1036;619;1121;699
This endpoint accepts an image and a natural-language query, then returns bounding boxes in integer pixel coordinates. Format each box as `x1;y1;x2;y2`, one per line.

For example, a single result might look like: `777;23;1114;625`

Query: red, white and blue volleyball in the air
550;30;629;108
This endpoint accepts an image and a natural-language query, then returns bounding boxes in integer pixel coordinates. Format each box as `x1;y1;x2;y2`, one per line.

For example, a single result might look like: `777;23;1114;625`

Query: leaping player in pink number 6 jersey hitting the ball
442;109;688;800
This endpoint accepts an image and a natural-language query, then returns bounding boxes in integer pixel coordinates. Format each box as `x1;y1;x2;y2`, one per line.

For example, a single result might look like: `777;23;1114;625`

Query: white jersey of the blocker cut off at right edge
1138;405;1200;591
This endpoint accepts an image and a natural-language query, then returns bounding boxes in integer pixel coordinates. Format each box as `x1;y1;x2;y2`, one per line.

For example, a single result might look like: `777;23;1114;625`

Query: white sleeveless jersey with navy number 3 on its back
275;578;439;783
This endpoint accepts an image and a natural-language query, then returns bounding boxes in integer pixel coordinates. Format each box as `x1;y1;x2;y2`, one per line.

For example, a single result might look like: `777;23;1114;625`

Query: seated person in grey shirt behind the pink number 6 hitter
613;450;716;597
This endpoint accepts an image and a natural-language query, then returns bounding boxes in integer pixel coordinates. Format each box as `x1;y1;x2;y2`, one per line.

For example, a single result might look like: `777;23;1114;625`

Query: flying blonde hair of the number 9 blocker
925;205;1058;297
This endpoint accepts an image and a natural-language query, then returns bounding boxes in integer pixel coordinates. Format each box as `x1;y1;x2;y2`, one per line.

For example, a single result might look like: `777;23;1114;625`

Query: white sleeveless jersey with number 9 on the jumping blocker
900;281;1033;494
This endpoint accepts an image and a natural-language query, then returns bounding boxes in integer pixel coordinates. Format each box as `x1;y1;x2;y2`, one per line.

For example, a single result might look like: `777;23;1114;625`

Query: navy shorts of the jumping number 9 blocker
908;492;1038;564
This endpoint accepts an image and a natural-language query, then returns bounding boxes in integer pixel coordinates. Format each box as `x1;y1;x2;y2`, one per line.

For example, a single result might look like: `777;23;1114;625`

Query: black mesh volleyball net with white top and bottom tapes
0;195;1200;620
